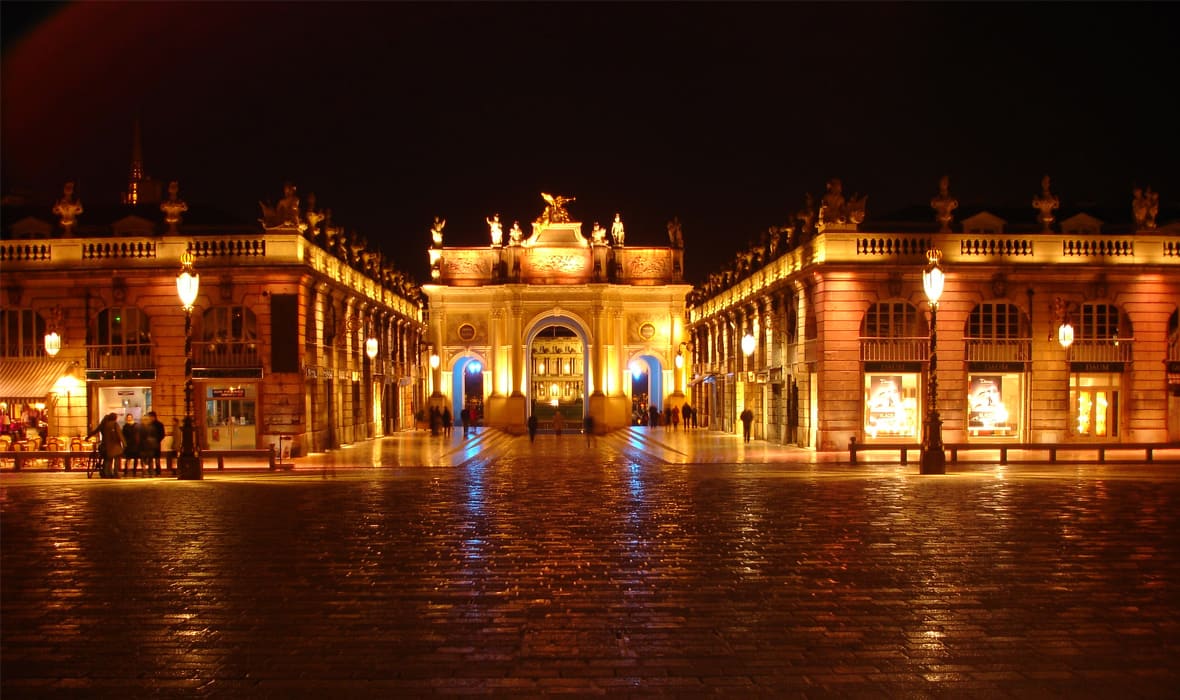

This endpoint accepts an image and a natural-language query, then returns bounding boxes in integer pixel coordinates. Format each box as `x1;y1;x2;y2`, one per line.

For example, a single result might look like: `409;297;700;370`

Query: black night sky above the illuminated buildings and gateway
0;1;1180;282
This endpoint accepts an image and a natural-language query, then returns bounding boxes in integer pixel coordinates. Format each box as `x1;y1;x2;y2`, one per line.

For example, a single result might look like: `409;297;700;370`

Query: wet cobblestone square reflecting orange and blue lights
0;430;1180;700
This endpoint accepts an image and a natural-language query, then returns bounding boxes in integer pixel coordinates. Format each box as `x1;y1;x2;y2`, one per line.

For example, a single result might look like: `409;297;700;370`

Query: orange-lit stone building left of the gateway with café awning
0;177;425;454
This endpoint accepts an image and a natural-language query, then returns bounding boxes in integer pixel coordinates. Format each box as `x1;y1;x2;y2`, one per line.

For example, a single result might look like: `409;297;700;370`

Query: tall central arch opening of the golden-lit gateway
525;315;590;430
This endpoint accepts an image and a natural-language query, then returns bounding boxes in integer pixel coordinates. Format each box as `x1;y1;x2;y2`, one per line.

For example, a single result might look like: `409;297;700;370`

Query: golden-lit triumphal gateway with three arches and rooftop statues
422;195;691;433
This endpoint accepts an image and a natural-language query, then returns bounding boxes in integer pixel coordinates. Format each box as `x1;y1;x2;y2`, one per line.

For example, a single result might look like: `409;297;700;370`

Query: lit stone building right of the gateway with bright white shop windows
688;178;1180;450
